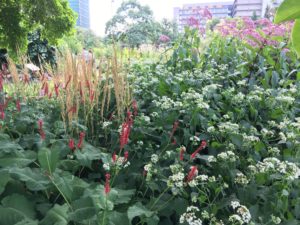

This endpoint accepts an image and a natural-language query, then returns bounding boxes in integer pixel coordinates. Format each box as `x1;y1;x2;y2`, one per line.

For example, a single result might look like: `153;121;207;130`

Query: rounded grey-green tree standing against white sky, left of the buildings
105;0;155;47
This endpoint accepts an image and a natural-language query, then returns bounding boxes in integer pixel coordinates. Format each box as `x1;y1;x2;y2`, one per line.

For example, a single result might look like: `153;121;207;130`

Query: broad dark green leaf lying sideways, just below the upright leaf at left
8;167;50;191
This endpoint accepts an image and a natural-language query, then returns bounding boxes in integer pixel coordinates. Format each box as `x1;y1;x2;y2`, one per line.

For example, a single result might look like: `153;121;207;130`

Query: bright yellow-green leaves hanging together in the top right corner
275;0;300;56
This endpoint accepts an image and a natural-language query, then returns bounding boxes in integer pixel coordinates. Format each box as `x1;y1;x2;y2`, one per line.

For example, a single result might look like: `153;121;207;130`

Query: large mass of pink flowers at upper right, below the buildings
216;17;293;47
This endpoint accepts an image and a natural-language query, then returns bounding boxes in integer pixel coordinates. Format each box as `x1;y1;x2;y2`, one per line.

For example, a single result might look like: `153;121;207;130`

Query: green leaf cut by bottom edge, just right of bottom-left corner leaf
40;204;69;225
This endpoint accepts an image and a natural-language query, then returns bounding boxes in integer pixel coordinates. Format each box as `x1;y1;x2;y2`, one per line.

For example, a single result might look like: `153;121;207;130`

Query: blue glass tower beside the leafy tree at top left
69;0;90;29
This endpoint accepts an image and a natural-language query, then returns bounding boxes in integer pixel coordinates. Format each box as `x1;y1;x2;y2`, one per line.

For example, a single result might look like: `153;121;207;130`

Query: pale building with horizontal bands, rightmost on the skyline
232;0;283;17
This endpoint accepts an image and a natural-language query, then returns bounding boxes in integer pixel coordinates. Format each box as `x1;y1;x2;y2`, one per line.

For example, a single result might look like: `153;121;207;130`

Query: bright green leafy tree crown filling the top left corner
0;0;76;53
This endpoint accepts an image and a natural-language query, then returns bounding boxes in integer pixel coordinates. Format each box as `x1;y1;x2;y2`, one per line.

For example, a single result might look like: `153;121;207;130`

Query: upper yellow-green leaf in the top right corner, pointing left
275;0;300;23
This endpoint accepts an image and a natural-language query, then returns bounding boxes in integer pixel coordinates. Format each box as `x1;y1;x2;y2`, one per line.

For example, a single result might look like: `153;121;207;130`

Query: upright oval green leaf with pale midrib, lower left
38;148;59;174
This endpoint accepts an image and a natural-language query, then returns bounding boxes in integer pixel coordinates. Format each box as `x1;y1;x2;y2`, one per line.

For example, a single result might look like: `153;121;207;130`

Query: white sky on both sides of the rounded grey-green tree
90;0;233;35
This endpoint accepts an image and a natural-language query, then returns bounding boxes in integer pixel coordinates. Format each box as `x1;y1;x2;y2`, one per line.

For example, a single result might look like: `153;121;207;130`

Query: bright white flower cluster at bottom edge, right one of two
229;201;251;224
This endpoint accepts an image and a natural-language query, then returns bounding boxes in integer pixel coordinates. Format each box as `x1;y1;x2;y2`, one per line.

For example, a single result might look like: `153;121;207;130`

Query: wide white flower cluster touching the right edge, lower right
256;157;300;180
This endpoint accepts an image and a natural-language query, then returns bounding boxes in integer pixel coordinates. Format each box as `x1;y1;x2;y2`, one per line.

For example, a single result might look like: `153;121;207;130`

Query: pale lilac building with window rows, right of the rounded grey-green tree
174;1;233;32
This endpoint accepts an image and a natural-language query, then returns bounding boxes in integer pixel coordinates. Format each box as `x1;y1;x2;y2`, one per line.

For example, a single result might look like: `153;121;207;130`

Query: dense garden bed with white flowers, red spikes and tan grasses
0;16;300;225
